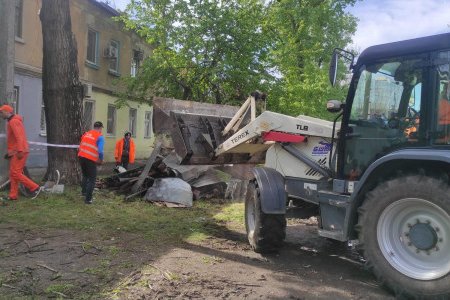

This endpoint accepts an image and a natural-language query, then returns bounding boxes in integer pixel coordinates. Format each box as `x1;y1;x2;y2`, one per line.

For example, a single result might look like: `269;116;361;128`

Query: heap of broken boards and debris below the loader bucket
98;146;251;207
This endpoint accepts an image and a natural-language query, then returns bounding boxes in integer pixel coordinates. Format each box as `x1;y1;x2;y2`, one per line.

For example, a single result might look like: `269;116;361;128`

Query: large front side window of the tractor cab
344;59;425;180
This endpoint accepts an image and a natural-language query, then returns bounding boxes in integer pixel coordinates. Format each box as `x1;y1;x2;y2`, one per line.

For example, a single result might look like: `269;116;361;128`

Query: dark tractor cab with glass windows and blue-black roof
330;34;450;181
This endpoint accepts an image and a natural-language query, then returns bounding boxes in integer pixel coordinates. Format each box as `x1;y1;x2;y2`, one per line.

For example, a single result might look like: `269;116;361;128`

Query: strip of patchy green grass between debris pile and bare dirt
0;187;244;245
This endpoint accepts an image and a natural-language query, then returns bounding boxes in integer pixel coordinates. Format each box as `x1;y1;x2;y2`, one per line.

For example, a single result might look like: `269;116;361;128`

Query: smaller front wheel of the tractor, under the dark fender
245;181;286;253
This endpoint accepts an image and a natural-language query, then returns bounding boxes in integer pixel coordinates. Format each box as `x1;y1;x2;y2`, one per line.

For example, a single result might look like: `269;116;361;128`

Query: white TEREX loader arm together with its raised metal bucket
153;94;333;165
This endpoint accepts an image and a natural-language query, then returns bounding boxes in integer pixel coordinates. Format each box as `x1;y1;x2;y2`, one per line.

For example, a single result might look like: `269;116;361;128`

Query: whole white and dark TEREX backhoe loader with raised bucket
154;33;450;299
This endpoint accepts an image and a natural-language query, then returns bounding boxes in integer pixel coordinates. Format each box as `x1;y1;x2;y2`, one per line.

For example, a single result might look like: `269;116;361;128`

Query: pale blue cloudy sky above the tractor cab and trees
109;0;450;51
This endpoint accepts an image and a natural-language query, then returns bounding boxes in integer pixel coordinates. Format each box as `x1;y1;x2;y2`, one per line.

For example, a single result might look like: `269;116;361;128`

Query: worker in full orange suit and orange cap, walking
0;104;42;200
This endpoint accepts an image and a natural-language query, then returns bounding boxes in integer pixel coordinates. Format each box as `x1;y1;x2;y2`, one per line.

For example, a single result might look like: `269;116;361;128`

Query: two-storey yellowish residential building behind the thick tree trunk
13;0;153;167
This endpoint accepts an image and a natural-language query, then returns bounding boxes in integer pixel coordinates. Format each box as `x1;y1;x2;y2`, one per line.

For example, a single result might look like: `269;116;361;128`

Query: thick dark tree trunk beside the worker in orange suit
40;0;83;184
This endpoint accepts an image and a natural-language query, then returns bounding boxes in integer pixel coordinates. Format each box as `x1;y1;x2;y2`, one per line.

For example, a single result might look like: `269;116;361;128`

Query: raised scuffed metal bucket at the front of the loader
153;98;264;165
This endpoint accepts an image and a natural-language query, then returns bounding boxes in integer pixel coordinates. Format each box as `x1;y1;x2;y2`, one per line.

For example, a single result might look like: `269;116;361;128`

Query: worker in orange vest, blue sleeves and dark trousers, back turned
78;121;105;204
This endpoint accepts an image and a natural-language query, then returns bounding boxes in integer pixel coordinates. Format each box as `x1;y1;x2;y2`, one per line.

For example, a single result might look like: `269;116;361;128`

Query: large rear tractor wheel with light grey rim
359;175;450;299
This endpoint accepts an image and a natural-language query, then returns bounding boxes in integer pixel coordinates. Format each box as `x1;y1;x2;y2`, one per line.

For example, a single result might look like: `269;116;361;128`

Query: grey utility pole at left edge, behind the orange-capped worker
0;0;16;184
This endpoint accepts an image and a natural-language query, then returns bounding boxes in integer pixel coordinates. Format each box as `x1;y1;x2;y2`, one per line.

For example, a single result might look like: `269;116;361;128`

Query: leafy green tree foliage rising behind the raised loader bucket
120;0;356;118
